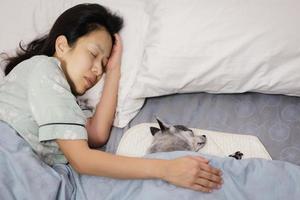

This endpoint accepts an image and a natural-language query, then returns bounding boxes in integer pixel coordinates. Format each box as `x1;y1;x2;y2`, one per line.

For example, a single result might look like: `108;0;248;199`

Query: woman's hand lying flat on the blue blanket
163;156;223;192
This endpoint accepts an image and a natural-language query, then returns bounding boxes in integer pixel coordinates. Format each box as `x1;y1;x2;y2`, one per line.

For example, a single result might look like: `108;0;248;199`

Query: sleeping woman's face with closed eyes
58;29;112;95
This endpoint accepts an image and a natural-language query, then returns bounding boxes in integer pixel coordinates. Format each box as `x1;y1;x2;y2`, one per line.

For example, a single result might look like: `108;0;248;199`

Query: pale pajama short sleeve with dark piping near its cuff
28;59;87;141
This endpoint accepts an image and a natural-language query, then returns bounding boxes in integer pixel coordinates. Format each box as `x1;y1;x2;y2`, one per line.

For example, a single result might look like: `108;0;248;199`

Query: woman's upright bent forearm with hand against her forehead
86;34;123;147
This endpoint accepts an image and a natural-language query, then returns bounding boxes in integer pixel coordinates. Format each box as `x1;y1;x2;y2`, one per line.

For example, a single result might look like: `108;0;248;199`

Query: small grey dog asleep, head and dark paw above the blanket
147;119;243;160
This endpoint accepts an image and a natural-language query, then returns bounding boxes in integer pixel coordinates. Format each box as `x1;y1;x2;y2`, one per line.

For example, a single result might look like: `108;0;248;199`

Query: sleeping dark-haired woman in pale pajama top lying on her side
0;4;223;192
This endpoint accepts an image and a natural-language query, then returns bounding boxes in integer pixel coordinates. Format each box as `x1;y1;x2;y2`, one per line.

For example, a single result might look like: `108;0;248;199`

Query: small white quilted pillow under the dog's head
116;123;272;160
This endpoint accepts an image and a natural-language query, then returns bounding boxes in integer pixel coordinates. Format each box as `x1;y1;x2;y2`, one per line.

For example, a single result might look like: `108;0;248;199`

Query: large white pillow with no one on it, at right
133;0;300;98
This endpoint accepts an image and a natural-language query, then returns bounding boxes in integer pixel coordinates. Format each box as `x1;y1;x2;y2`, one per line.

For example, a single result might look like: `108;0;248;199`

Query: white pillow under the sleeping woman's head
0;0;149;127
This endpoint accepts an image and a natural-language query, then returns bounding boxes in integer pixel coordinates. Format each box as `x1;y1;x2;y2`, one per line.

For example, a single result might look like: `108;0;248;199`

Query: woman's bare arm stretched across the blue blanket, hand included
56;140;222;192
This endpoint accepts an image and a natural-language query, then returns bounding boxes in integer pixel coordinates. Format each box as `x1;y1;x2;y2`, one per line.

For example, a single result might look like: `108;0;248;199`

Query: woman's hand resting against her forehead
106;34;123;74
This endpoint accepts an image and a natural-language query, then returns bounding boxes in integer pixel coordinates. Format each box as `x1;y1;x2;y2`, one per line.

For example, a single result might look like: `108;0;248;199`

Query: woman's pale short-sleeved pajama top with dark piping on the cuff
0;56;91;165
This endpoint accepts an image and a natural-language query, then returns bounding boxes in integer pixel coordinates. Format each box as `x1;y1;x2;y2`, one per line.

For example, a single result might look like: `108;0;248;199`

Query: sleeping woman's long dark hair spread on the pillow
4;4;123;75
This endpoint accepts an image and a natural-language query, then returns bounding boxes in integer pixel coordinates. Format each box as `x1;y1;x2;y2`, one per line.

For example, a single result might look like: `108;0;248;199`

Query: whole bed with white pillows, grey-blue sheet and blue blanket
0;0;300;200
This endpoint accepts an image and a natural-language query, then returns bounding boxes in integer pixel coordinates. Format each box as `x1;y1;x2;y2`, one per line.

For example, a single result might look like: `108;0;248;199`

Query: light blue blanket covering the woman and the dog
0;122;300;200
